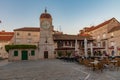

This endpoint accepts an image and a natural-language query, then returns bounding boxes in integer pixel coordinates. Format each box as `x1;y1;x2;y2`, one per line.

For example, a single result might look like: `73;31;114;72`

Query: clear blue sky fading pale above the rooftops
0;0;120;34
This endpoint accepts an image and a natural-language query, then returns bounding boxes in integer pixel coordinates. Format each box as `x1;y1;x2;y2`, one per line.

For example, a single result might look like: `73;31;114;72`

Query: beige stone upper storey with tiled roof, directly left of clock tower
14;27;40;45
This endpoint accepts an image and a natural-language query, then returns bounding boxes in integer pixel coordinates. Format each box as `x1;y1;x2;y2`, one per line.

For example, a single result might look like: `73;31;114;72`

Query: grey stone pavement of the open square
0;59;120;80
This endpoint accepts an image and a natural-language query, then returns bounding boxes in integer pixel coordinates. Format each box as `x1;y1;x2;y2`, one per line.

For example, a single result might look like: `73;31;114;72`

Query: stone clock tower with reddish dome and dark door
39;9;54;59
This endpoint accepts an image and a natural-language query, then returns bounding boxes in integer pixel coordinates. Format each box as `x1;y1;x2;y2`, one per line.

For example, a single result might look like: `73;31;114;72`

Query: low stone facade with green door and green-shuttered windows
8;49;38;61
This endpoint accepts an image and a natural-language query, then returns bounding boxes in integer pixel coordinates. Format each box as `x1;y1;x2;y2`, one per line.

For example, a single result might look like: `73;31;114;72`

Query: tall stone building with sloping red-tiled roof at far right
80;18;120;56
